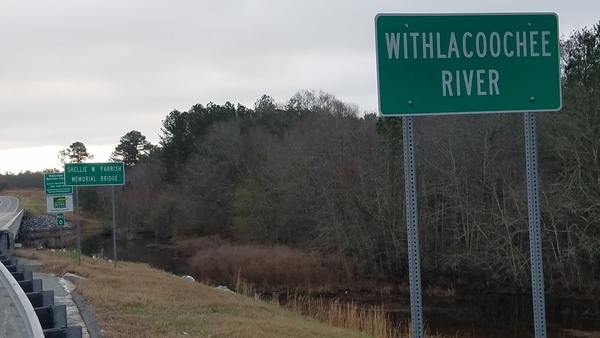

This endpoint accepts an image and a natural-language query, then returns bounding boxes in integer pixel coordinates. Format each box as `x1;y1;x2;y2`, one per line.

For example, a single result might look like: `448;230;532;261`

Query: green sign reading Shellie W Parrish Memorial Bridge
65;162;125;186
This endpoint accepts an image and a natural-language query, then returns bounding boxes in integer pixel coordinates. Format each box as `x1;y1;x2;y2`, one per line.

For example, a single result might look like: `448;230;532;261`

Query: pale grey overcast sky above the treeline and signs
0;0;600;173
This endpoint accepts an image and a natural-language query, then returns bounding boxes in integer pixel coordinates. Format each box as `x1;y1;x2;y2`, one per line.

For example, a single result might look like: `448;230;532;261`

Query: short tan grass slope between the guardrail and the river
16;250;376;338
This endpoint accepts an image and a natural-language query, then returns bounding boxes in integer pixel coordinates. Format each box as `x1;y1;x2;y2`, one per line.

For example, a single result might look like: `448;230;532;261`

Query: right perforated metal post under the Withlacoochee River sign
524;113;546;338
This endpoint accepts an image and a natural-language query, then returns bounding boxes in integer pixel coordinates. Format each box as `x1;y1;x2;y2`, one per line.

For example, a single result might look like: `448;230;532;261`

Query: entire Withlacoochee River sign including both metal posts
375;13;562;338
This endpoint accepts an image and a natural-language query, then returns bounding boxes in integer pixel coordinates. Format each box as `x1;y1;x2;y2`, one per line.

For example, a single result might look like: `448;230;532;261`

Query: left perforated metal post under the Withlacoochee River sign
402;116;423;338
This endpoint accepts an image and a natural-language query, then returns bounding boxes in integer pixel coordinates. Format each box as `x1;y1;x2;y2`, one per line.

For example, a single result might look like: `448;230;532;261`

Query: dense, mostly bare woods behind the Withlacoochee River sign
3;25;600;292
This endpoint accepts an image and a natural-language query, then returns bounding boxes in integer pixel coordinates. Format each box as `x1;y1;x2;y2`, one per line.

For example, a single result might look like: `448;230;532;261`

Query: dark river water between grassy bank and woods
82;237;600;338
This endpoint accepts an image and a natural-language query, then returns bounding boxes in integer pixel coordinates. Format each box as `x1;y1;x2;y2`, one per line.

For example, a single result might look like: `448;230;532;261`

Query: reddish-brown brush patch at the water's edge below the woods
177;237;353;293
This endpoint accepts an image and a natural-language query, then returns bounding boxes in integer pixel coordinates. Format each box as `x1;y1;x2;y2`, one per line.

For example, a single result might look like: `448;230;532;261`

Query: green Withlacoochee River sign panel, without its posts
375;13;562;116
